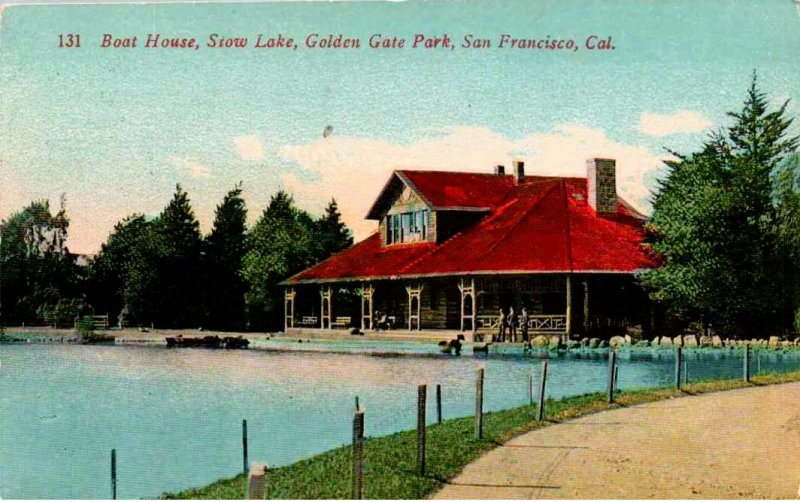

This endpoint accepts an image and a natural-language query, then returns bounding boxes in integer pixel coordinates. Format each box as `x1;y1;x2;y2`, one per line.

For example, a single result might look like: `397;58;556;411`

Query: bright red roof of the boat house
286;171;655;284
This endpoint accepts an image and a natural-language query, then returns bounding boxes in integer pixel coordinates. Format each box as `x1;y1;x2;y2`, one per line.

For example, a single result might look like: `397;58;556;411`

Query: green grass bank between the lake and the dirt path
161;372;800;499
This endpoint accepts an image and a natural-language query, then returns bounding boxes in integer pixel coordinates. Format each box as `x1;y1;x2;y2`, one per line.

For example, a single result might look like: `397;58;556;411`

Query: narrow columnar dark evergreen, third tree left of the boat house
203;184;247;331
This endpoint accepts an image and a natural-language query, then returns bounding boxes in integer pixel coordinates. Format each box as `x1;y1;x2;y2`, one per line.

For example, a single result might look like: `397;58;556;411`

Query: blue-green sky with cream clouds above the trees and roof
0;0;800;252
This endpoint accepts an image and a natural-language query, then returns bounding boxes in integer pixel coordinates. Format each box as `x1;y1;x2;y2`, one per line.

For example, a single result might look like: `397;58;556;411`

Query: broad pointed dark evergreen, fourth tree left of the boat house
125;185;203;327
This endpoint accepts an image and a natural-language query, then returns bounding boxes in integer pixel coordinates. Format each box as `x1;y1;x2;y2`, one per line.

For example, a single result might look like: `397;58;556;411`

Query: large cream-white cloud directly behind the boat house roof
278;124;662;239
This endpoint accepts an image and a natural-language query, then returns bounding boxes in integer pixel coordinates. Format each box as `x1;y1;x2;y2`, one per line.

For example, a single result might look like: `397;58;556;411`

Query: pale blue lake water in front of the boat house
0;341;800;499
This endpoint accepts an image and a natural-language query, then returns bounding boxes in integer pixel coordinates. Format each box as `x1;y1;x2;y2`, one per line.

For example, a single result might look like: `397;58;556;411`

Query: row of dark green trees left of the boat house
0;185;353;331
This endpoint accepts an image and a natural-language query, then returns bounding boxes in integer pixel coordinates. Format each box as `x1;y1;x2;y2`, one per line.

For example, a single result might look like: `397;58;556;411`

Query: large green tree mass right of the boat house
641;73;800;334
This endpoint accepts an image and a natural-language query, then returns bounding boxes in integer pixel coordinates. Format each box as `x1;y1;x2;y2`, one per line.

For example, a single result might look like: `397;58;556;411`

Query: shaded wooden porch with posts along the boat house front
284;274;649;336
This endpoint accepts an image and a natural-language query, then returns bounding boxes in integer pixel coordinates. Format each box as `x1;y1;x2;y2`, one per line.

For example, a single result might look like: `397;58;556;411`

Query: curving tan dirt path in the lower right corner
434;383;800;499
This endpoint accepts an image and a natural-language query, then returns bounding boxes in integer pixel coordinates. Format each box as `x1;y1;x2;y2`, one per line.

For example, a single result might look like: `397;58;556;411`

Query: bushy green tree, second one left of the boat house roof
242;191;317;329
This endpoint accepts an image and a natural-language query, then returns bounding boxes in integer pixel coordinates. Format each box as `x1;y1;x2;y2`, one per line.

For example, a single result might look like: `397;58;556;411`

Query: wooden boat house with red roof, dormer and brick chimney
282;158;654;342
